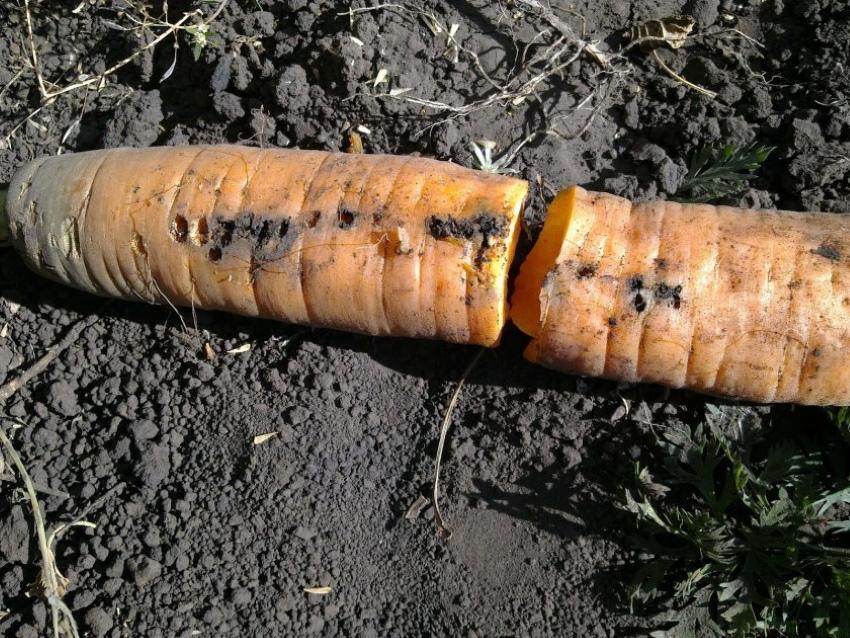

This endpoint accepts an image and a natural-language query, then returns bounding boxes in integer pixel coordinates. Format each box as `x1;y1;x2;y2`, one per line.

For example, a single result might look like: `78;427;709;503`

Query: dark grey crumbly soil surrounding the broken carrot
0;0;850;638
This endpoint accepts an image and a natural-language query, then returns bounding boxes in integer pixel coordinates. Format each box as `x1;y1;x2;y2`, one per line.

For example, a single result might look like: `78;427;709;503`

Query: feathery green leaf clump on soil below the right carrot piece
622;426;850;638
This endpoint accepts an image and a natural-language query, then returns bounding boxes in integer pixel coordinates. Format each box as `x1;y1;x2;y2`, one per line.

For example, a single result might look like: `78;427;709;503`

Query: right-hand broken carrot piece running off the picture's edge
511;187;850;405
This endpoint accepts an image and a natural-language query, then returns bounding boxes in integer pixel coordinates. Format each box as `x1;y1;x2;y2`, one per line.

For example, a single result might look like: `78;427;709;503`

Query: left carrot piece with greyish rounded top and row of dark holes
0;146;527;346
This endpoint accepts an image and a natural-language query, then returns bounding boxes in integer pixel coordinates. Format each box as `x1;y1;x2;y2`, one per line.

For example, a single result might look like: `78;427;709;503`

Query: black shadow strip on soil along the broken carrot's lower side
0;249;780;418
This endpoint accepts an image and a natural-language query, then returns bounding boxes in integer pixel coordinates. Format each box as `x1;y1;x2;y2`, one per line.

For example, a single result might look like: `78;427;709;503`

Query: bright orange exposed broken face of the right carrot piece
511;186;576;337
